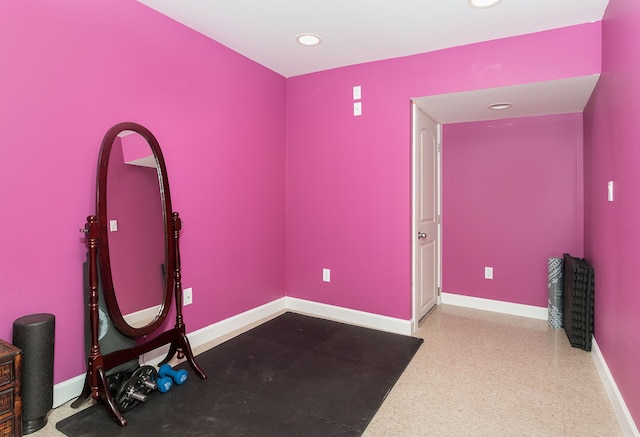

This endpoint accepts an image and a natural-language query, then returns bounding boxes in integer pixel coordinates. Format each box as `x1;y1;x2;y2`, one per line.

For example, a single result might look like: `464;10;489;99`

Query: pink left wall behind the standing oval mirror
0;0;286;382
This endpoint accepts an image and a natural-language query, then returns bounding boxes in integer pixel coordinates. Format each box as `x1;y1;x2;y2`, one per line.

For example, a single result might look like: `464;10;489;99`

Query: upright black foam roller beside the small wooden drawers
13;314;55;434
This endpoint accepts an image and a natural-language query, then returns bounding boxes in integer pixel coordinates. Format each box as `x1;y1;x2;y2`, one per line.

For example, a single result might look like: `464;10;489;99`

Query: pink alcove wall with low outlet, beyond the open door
442;114;583;307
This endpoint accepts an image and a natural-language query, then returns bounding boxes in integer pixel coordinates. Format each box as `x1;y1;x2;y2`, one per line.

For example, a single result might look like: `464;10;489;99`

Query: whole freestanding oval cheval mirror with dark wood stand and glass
71;122;206;426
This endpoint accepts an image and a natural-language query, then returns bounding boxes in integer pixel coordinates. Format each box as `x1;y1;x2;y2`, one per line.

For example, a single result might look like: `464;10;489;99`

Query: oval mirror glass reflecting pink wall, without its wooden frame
107;132;165;326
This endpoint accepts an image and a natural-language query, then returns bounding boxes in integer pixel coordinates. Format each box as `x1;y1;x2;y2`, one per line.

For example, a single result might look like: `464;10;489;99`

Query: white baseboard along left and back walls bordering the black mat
53;297;411;408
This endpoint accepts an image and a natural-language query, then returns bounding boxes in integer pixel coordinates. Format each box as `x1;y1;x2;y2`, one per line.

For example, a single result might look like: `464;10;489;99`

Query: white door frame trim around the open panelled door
411;99;442;333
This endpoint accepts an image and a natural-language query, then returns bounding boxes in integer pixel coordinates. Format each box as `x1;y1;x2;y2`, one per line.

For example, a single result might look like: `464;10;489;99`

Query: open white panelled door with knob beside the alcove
413;104;440;328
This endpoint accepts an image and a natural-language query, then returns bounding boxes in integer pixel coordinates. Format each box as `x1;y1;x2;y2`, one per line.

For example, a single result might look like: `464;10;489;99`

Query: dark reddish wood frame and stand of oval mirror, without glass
71;122;206;426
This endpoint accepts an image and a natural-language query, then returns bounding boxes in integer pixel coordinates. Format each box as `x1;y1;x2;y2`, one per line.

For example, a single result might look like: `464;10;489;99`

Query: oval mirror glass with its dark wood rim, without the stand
98;123;173;336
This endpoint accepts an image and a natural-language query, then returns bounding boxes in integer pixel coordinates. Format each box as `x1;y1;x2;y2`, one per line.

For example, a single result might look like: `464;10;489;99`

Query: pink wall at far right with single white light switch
584;0;640;426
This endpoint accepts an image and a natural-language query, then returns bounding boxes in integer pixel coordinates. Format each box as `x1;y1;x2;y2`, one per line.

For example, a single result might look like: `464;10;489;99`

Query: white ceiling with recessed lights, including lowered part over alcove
138;0;608;121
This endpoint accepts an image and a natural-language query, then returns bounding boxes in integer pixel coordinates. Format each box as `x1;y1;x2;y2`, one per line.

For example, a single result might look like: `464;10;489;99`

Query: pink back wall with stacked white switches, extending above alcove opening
285;23;601;320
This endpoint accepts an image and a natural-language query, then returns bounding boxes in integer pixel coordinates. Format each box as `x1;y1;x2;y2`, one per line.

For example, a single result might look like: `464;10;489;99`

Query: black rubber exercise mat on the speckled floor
56;313;423;437
